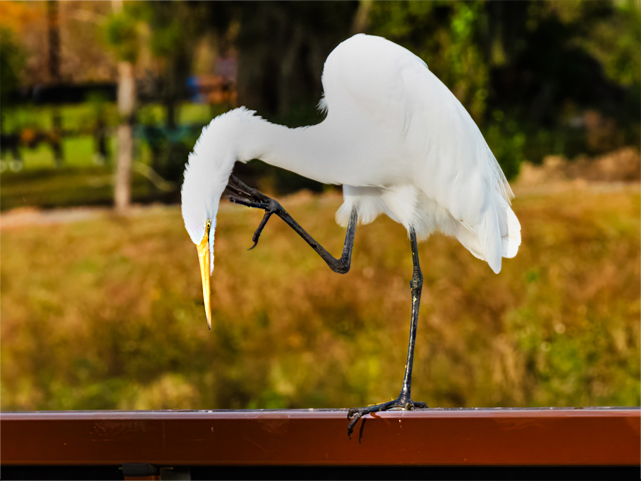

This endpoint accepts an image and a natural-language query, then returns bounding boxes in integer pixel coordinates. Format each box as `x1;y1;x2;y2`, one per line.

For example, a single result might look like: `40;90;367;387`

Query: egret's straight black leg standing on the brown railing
347;229;427;436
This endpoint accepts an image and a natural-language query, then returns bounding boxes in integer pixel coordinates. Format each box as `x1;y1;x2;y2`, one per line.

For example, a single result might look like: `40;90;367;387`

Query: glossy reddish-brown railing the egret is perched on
1;408;641;479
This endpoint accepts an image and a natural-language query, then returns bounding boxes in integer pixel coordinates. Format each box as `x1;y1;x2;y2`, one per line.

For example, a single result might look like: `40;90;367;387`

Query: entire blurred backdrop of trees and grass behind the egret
0;0;641;410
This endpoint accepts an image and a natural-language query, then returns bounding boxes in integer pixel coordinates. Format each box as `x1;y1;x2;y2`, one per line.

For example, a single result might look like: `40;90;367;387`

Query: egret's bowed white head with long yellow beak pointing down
181;115;244;329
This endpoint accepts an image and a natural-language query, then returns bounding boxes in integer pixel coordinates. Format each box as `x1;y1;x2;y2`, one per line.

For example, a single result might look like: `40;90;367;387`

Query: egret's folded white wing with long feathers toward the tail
403;65;521;272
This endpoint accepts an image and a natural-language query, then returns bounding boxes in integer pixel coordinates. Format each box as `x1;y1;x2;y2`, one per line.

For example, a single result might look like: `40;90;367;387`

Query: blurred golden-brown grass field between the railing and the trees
0;186;640;410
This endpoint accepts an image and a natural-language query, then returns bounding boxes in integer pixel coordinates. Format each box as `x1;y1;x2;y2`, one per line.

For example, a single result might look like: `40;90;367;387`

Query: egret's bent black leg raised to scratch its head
227;175;358;274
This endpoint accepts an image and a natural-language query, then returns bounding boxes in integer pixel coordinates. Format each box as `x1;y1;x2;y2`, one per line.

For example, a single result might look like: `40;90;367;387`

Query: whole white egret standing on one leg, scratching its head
182;34;521;433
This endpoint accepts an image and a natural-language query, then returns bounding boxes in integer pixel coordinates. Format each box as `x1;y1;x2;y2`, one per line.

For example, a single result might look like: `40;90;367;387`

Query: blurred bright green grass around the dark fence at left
0;103;222;210
